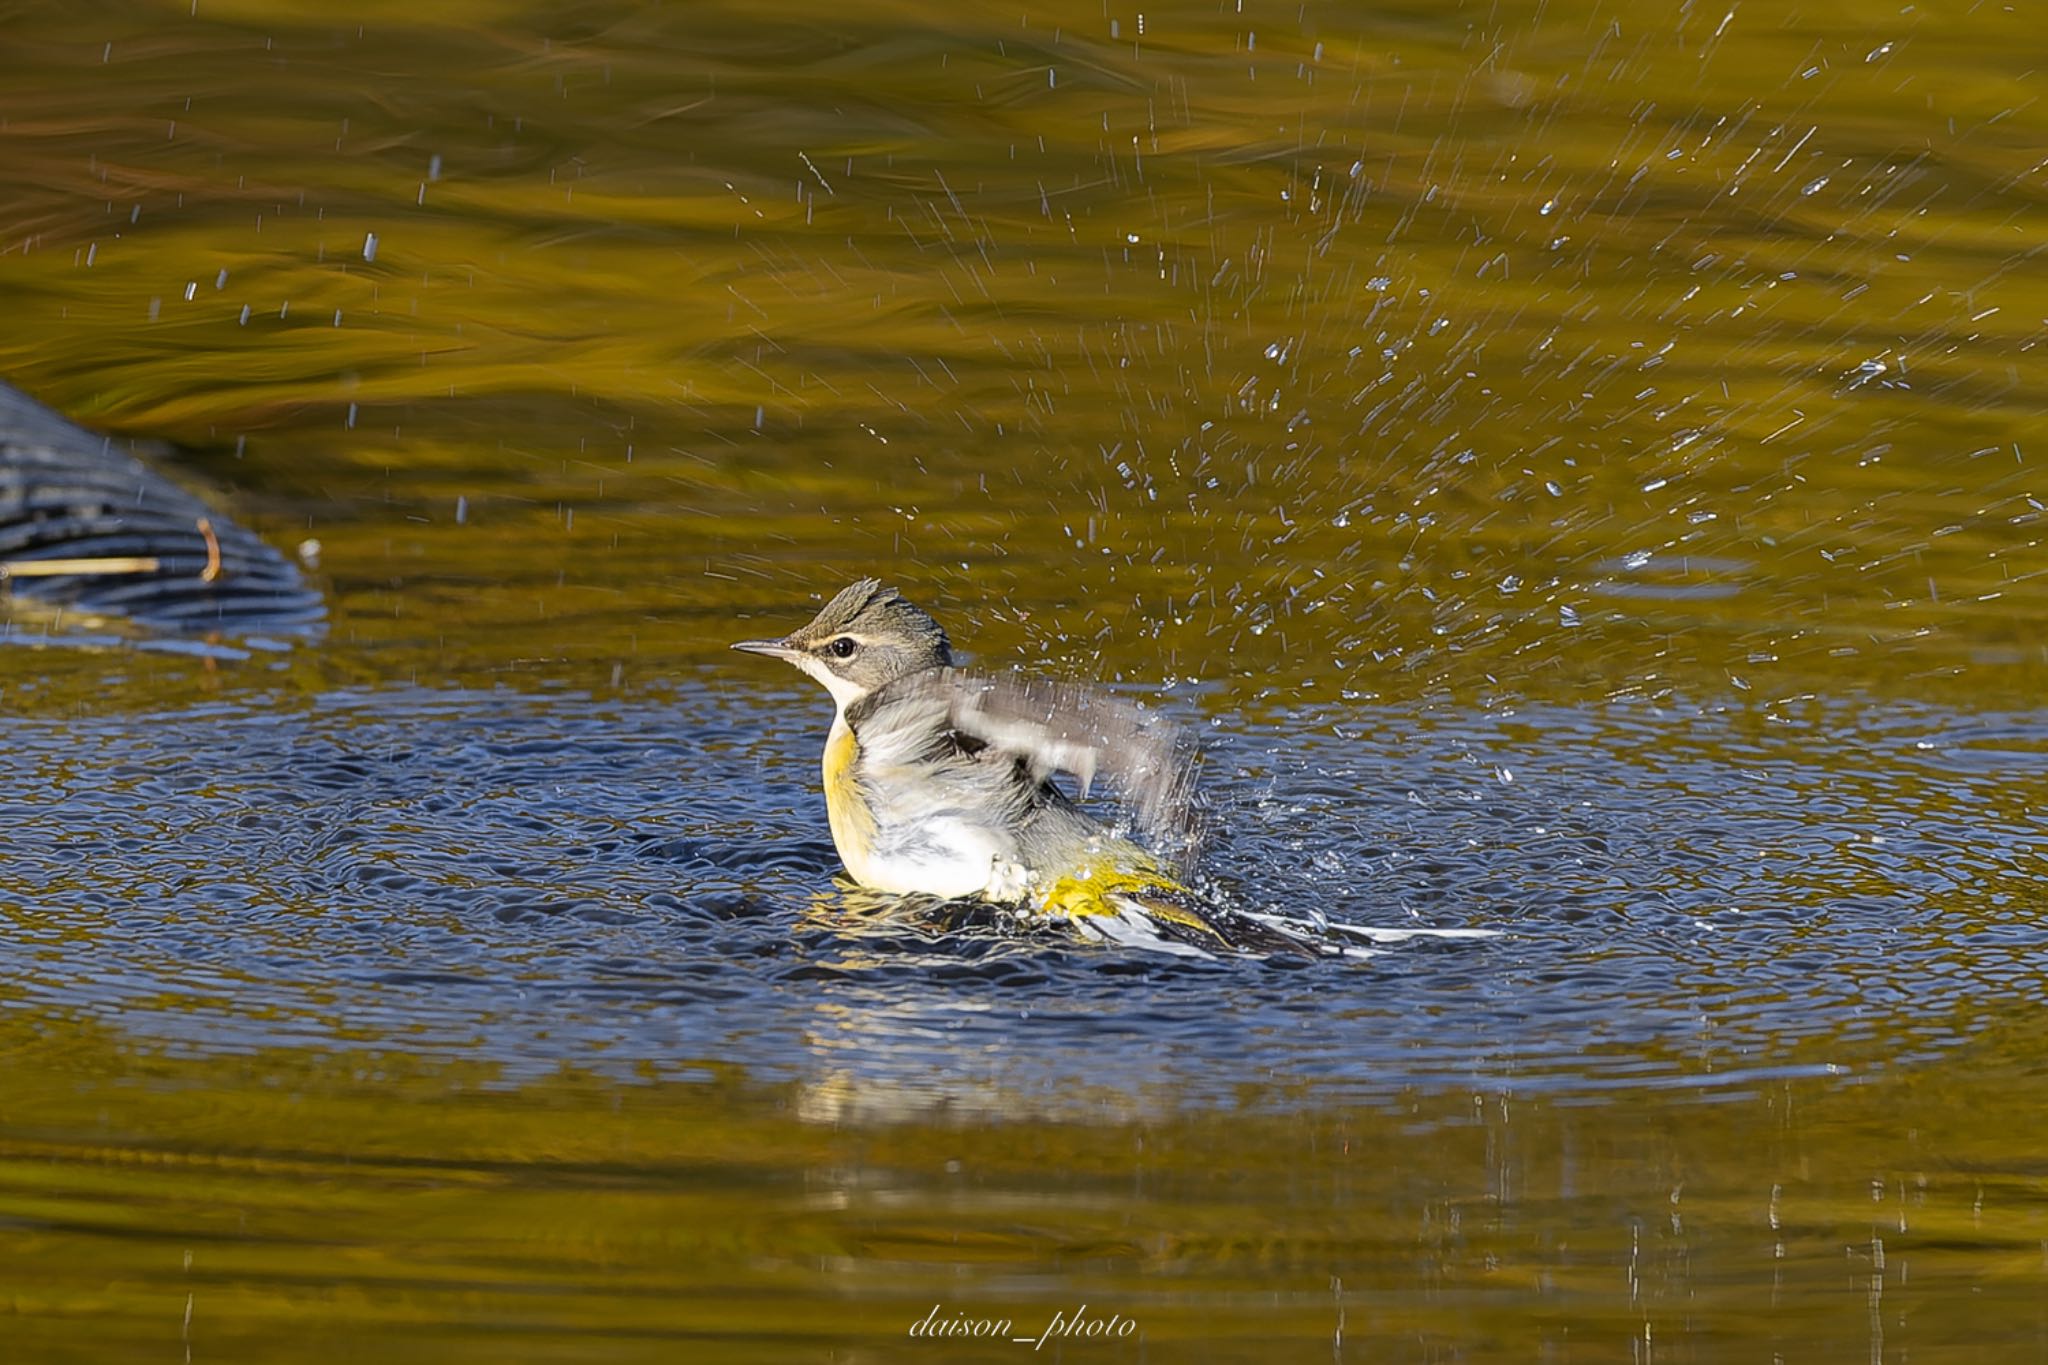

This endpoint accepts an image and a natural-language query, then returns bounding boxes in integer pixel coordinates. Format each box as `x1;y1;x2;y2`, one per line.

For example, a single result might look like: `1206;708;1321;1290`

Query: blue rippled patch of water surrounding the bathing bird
0;690;2048;1113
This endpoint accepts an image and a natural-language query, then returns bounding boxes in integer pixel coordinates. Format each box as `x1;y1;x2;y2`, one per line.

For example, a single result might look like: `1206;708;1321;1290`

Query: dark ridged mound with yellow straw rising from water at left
0;385;326;630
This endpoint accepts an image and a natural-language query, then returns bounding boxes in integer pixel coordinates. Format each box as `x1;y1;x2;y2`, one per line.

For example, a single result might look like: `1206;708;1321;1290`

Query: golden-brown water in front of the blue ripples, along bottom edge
0;1013;2048;1361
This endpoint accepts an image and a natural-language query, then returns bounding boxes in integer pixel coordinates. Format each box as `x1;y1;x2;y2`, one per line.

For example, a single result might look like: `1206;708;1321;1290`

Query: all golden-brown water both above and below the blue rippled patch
0;0;2048;1361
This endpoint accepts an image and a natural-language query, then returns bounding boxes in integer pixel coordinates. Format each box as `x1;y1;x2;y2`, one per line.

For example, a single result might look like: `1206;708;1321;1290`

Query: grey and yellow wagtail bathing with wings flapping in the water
733;579;1305;950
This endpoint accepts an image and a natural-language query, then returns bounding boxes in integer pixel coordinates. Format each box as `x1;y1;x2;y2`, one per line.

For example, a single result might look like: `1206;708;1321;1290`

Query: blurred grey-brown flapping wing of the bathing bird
860;669;1200;853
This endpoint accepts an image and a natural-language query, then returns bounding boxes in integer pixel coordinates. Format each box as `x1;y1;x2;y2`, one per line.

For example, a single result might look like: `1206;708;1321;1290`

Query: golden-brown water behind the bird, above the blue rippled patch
0;4;2044;696
